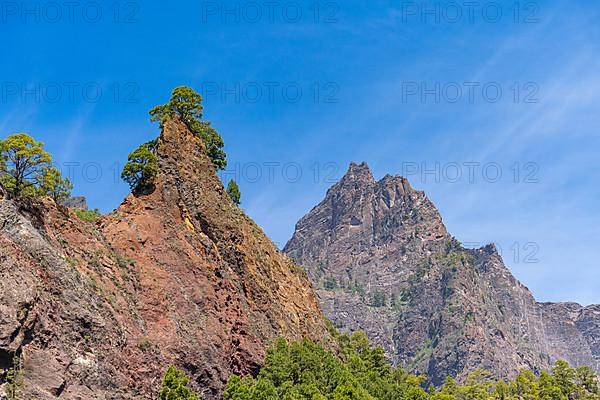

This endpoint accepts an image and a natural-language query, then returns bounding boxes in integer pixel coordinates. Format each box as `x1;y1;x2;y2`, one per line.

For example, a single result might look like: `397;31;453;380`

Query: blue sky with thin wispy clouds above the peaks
0;0;600;304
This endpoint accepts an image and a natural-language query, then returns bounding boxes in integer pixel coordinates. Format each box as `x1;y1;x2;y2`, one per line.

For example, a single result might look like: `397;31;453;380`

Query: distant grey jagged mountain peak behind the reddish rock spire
284;163;600;384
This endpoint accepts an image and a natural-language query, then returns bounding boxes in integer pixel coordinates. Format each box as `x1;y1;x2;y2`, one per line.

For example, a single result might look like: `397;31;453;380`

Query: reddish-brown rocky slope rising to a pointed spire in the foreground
0;121;330;400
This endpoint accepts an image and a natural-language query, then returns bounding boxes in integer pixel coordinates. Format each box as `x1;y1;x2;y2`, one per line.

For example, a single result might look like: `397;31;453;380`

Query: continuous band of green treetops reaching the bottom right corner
224;329;600;400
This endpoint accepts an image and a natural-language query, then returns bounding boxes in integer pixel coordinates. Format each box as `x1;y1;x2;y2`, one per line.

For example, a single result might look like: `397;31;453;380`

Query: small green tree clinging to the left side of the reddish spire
121;140;158;191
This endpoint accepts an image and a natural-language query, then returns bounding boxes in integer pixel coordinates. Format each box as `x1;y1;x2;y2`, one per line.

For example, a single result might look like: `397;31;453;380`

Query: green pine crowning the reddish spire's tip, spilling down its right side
150;86;227;170
